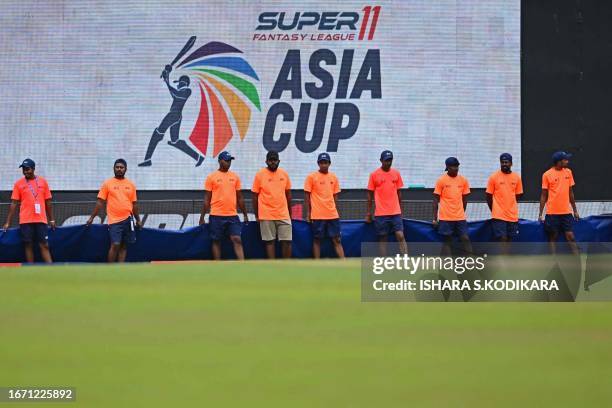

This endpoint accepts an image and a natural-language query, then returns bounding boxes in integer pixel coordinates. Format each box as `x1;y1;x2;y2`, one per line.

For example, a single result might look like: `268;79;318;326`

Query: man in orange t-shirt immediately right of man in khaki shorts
304;153;344;259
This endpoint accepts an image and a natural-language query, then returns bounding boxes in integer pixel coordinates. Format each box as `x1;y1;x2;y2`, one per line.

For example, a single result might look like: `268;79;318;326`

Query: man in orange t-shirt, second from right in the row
486;153;523;242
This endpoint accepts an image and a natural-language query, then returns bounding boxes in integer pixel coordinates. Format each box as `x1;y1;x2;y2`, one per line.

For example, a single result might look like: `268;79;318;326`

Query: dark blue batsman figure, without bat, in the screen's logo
138;69;204;167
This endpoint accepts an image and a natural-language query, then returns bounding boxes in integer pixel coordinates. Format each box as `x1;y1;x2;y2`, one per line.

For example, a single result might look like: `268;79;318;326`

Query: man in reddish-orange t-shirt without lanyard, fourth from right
366;150;408;256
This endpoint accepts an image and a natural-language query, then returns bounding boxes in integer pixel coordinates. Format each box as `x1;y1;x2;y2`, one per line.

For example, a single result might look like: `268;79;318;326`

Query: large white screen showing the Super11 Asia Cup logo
0;0;521;190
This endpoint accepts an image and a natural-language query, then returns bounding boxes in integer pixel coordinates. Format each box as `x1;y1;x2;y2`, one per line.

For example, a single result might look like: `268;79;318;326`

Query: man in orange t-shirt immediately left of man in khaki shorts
200;151;249;260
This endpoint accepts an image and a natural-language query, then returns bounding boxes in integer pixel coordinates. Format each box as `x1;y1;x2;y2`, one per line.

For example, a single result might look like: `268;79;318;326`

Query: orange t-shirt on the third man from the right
434;174;470;221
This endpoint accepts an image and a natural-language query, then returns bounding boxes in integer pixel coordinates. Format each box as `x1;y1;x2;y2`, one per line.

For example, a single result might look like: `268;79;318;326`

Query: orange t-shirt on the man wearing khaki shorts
251;167;291;220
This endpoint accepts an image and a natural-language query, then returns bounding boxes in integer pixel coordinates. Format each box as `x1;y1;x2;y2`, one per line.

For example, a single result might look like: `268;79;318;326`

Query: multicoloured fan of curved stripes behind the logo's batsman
177;42;261;156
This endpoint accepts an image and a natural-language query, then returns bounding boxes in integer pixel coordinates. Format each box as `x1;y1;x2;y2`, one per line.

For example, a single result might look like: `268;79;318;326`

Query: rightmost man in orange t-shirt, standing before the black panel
538;152;580;254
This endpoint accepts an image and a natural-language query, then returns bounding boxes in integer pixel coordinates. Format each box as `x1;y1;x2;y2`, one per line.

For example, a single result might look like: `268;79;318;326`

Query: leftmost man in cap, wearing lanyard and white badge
3;159;55;263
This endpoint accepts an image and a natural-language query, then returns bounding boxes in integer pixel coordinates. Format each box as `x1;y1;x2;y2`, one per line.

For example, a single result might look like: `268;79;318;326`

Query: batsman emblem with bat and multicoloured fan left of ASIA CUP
138;36;261;167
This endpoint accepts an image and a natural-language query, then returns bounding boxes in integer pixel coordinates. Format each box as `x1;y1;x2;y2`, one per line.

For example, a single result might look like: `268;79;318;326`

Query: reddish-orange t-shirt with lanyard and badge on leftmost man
11;176;51;224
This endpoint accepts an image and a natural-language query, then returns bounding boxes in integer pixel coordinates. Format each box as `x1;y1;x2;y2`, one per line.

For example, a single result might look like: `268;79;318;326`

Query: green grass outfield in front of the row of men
0;261;612;407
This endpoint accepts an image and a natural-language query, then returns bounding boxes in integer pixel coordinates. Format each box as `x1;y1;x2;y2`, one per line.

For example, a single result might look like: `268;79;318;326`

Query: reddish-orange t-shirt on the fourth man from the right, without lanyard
368;167;404;217
